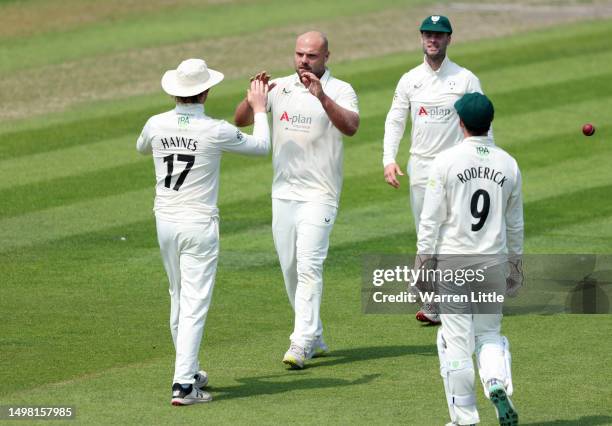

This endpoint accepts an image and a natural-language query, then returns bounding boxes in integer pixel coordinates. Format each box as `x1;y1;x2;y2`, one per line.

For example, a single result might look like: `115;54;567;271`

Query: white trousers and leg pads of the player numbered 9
437;264;512;425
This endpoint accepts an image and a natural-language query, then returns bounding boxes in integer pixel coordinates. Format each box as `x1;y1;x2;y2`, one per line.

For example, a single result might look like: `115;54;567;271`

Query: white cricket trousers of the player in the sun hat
156;218;219;384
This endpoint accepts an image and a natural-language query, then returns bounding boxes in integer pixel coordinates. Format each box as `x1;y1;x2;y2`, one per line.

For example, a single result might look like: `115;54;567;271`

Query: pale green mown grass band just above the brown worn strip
0;0;419;73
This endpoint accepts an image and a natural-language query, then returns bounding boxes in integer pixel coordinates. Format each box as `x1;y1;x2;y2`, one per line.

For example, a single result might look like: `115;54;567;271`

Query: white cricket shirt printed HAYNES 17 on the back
136;104;270;222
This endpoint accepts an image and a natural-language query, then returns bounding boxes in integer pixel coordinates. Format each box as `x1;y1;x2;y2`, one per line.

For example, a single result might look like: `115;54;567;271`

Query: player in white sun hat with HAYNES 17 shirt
136;59;270;405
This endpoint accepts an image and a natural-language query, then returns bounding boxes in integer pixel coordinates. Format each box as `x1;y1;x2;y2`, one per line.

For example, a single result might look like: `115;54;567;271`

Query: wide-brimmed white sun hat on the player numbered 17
162;59;224;97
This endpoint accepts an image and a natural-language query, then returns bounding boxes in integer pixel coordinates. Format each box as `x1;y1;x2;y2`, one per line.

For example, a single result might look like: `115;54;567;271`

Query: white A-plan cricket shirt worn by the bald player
268;70;359;207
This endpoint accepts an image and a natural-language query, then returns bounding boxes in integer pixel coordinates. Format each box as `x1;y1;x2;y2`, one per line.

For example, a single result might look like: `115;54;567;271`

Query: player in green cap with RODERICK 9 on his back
417;93;523;426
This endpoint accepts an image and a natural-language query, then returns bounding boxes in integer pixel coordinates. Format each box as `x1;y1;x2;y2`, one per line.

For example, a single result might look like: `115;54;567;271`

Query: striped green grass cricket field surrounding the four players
0;0;612;426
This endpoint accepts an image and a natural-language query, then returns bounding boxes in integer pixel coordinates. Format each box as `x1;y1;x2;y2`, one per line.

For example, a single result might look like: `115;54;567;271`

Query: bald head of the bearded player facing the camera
294;31;329;78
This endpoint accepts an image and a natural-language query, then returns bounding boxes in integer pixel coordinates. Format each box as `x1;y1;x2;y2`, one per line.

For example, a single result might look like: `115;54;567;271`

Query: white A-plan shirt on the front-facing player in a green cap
383;56;482;167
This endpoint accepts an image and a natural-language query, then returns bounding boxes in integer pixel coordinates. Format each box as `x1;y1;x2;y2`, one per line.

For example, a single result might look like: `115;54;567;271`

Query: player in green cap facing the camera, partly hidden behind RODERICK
383;15;482;324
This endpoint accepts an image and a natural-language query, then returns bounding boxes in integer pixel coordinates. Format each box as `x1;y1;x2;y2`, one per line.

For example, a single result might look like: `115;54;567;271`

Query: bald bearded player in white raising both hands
235;31;359;369
